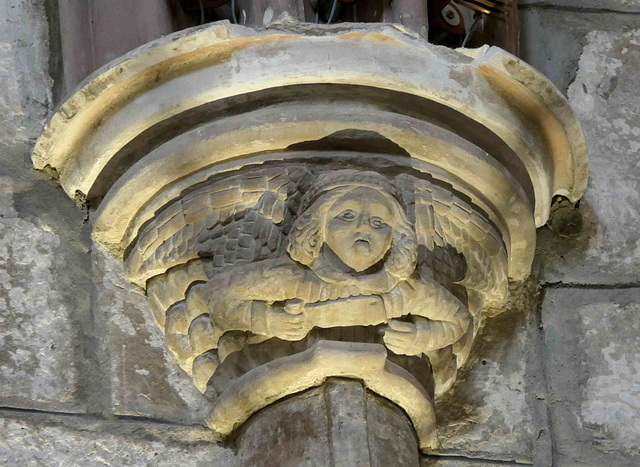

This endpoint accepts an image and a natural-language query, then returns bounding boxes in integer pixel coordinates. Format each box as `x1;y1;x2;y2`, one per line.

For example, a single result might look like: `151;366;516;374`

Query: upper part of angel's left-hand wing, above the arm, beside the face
125;167;302;286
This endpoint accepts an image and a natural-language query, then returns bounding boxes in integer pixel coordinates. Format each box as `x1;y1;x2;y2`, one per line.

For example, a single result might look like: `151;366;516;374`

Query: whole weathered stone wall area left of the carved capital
0;0;235;466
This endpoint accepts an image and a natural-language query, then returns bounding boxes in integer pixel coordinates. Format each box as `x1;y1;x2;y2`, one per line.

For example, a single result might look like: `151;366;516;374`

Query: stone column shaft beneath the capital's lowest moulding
236;378;419;467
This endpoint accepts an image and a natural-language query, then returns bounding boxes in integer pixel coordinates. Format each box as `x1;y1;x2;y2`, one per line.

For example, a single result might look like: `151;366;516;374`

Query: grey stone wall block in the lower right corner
542;288;640;466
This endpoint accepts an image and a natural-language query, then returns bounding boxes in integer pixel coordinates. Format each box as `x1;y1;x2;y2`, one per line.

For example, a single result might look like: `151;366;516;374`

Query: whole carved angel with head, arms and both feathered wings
127;167;506;392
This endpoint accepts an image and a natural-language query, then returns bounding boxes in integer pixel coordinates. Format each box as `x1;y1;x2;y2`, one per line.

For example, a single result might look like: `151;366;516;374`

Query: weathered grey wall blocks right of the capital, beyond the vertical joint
520;0;640;466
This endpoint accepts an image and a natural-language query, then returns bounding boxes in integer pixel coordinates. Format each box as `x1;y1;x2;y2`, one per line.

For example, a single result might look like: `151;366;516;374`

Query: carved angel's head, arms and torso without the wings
190;170;471;355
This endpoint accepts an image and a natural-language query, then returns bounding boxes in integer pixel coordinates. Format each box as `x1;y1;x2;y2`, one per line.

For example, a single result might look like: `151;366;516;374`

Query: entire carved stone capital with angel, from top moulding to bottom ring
33;22;588;449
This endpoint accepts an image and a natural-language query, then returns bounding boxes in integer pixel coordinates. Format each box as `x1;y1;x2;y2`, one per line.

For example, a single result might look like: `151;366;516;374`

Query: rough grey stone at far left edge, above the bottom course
0;0;91;412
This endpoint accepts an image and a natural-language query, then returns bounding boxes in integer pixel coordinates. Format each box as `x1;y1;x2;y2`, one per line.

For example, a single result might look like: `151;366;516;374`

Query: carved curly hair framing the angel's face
288;180;418;280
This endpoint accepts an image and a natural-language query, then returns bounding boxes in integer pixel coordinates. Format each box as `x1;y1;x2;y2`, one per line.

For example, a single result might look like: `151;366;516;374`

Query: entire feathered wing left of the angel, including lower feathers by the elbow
125;167;307;392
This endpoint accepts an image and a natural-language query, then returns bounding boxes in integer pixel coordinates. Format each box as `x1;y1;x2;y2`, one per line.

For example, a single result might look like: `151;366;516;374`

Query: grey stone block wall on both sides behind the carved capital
0;0;640;466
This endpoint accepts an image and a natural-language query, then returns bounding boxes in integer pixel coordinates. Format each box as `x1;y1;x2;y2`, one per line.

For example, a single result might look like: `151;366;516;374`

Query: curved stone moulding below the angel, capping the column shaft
207;341;437;449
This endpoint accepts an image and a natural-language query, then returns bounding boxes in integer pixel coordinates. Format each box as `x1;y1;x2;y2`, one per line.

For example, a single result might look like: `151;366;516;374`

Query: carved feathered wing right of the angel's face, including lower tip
399;175;508;394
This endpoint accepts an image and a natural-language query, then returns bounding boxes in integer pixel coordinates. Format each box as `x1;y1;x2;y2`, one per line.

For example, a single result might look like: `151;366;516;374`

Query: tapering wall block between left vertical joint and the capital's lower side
92;245;209;423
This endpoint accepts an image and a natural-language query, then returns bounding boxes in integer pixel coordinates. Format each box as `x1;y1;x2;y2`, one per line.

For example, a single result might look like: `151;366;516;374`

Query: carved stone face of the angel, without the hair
325;187;396;272
